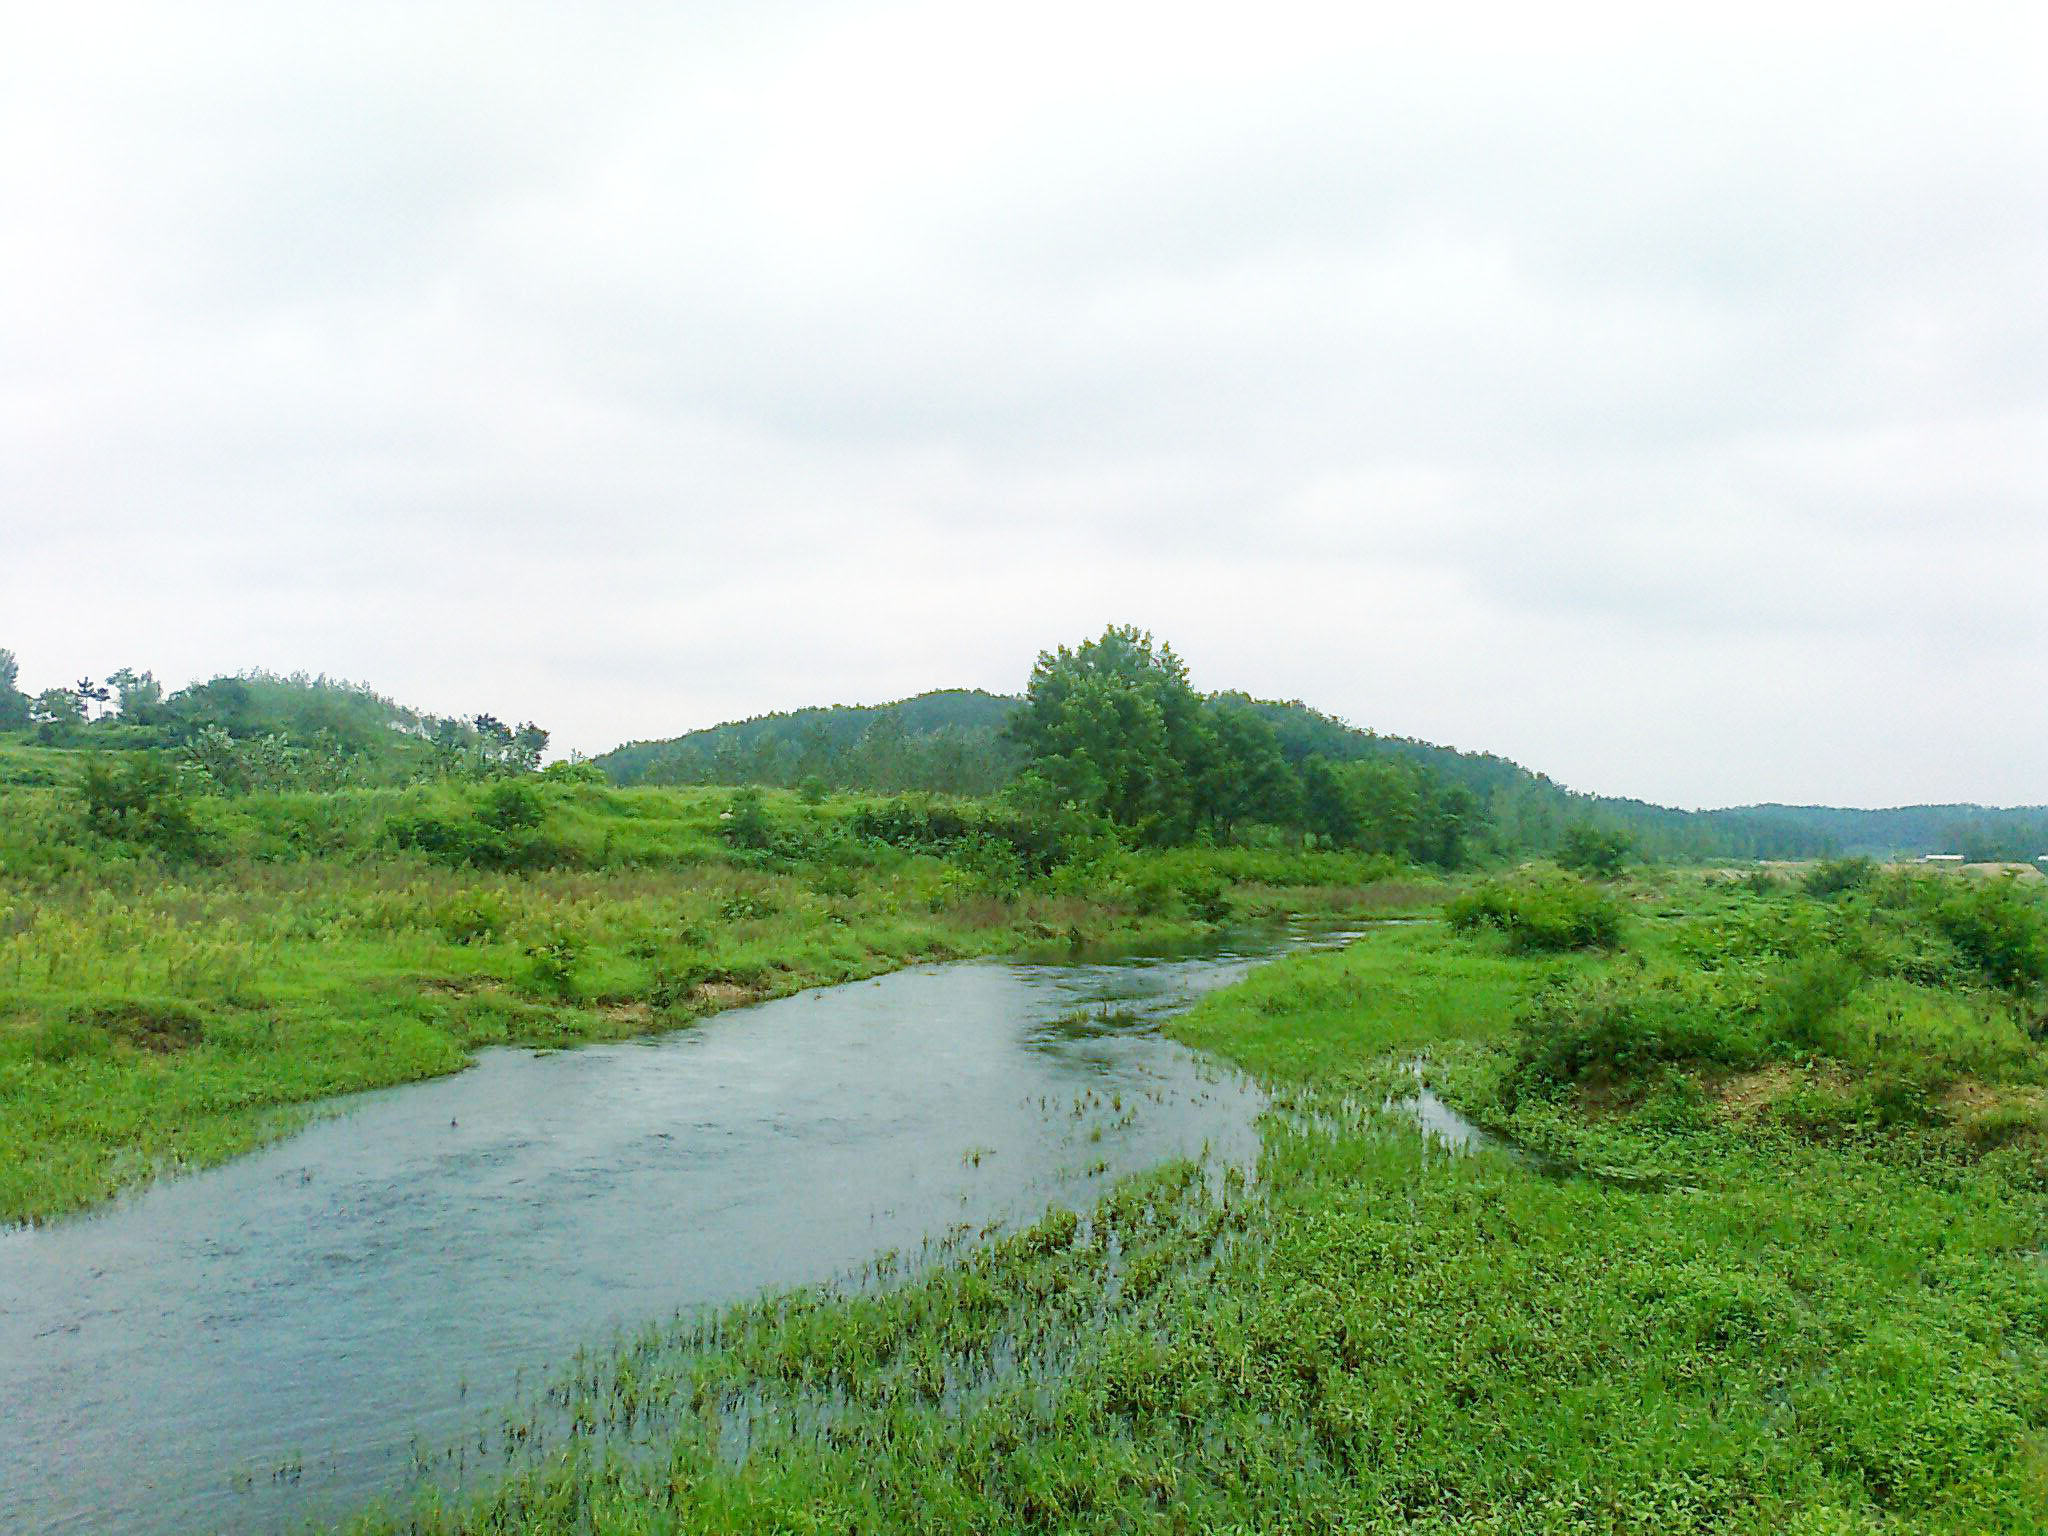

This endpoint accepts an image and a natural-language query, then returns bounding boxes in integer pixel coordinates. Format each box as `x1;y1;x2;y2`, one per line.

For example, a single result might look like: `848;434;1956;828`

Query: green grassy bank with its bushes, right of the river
348;881;2048;1534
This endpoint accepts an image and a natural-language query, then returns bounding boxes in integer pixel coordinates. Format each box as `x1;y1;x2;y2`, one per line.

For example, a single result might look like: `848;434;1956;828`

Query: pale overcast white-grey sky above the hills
0;0;2048;805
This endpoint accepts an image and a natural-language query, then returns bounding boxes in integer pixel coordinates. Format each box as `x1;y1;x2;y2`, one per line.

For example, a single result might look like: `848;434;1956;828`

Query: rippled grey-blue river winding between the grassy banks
0;934;1343;1536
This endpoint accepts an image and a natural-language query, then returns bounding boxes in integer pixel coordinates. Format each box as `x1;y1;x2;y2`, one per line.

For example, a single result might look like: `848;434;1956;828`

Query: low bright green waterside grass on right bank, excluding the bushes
339;922;2048;1536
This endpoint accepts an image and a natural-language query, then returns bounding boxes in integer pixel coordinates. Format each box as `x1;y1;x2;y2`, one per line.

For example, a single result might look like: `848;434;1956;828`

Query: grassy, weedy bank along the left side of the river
0;782;1434;1223
